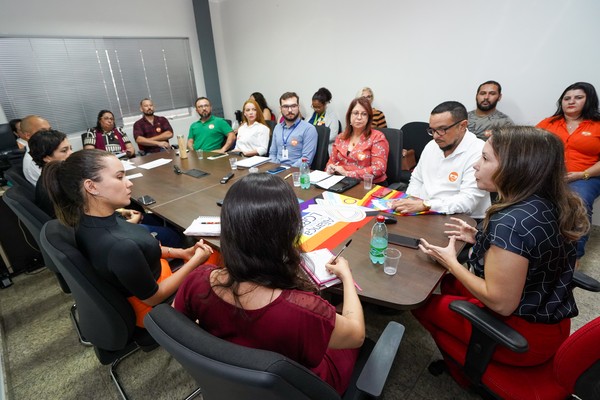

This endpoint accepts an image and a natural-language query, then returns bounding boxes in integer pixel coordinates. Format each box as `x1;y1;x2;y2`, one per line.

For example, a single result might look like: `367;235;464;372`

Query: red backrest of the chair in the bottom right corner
554;317;600;399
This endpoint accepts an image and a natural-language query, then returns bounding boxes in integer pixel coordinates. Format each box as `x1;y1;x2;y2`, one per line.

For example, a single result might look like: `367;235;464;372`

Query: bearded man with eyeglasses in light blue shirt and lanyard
269;92;317;167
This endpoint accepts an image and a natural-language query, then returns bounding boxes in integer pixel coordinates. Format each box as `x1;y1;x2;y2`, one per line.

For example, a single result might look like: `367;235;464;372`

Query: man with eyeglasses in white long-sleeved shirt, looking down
392;101;491;219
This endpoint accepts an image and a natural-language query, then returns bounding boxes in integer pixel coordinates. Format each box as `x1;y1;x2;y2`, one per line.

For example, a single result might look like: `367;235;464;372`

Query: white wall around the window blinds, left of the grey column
0;0;205;143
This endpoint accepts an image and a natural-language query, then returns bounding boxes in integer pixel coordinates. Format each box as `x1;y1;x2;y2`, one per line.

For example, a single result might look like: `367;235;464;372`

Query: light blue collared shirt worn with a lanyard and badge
269;119;317;167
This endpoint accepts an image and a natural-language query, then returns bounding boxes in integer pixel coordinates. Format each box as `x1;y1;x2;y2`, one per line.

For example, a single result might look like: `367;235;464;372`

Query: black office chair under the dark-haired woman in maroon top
144;304;404;400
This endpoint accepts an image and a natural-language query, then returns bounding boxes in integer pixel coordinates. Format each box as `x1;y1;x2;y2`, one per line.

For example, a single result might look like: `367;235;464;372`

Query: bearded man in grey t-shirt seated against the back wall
468;81;514;140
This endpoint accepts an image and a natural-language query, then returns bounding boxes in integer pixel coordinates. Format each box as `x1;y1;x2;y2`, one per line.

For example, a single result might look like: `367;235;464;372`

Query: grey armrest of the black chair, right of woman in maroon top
356;321;404;397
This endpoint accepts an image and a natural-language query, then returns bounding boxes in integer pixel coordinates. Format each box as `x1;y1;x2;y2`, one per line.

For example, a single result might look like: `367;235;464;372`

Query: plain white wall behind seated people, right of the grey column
211;0;600;127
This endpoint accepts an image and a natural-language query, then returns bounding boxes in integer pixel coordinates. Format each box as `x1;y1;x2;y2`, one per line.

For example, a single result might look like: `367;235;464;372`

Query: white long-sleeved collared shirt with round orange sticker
406;131;491;219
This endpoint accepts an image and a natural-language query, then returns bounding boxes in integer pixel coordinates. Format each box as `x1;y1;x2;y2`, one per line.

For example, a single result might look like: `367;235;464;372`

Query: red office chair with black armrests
429;272;600;400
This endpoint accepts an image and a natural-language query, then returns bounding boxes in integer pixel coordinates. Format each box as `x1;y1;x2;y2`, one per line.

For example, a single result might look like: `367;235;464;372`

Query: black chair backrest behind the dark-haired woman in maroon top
144;304;340;400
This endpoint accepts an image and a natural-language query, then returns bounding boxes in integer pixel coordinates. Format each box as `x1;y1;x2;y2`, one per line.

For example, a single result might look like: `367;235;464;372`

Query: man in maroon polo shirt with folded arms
133;98;173;153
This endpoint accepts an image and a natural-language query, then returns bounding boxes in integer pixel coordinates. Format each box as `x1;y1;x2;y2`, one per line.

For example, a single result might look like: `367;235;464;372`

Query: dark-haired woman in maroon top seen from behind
174;174;365;394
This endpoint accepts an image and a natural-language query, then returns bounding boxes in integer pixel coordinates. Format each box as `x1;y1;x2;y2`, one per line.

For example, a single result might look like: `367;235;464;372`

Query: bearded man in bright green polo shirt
188;97;235;153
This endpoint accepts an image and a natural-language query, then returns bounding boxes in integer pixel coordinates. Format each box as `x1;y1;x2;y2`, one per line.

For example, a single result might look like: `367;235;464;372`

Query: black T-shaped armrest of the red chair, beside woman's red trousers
450;300;529;385
